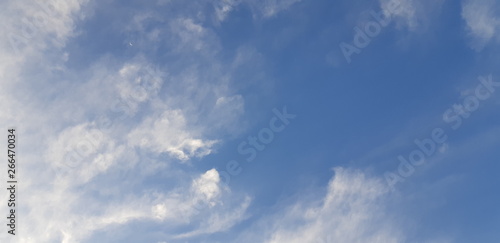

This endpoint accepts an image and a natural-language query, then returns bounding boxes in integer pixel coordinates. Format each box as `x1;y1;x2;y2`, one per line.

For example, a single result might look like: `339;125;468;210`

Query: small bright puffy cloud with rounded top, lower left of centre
152;169;251;239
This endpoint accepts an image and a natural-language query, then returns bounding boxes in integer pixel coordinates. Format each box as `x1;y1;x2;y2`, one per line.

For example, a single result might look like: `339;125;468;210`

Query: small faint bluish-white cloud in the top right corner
462;0;500;51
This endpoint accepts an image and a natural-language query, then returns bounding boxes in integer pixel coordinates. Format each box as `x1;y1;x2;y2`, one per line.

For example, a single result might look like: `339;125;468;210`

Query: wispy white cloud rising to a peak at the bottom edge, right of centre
237;167;455;243
